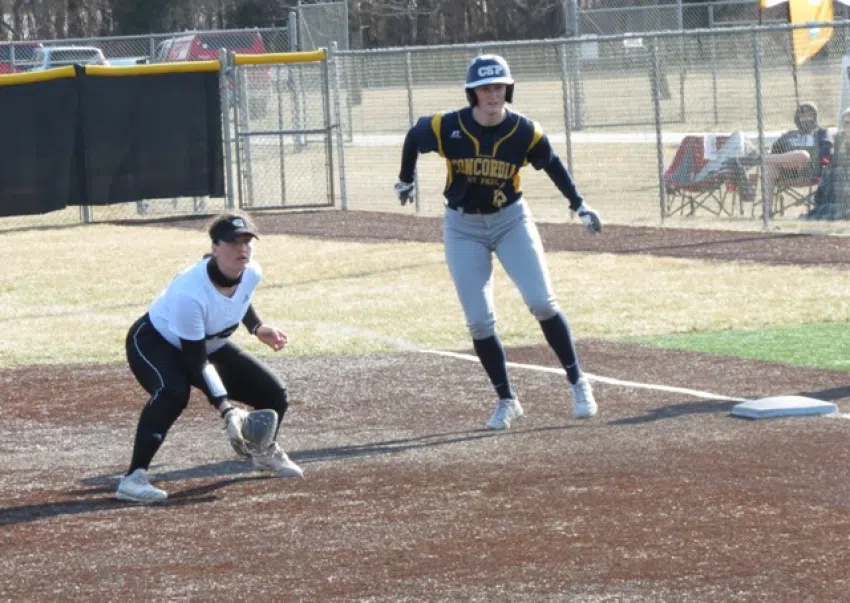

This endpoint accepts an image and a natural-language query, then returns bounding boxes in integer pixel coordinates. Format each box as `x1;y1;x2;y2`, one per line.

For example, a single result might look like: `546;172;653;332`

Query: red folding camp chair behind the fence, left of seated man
664;136;732;216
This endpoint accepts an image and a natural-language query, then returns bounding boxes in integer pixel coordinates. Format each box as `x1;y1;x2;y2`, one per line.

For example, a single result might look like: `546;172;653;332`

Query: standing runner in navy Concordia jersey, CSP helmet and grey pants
395;55;602;429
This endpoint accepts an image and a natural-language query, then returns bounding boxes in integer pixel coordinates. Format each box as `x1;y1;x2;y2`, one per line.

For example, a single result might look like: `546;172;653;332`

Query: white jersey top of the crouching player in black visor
148;258;262;354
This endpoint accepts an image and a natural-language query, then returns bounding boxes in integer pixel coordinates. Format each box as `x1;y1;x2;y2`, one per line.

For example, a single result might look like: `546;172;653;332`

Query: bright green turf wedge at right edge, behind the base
628;323;850;371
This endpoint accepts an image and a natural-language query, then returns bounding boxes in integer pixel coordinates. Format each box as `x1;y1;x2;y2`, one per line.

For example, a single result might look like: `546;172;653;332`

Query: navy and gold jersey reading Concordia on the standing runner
402;107;564;213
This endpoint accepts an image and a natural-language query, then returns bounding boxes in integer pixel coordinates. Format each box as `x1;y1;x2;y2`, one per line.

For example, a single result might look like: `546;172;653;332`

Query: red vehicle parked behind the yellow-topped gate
157;31;272;118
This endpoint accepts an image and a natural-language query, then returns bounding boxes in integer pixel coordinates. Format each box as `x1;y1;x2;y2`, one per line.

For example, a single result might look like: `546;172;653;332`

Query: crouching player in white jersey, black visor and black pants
116;214;302;502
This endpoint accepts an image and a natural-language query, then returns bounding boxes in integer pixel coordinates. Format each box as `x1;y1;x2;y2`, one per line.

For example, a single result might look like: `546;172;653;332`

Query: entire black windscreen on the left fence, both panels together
0;67;225;216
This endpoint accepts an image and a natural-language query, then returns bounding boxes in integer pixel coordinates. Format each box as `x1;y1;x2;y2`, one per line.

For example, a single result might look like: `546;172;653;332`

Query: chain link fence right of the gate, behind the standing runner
336;22;850;231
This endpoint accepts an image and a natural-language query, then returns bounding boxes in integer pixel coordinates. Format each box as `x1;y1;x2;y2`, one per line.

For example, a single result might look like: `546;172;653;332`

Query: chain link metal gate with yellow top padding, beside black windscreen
222;50;341;211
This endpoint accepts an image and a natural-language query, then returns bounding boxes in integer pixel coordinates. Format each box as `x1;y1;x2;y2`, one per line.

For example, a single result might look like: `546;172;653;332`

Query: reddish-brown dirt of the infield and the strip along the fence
0;212;850;602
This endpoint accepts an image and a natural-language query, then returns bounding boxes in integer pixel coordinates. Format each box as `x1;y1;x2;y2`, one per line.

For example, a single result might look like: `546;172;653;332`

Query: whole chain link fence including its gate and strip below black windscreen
8;22;850;232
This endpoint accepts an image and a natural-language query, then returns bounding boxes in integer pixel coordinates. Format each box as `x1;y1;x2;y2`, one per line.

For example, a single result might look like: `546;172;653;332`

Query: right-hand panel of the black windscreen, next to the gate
82;72;224;205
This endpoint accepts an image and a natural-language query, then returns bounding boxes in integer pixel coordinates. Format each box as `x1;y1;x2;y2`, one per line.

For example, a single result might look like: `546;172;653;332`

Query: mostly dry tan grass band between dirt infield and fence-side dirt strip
0;225;850;367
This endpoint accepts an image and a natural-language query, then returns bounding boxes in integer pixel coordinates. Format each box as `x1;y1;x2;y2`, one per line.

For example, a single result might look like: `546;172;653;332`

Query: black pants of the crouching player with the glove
126;314;288;472
